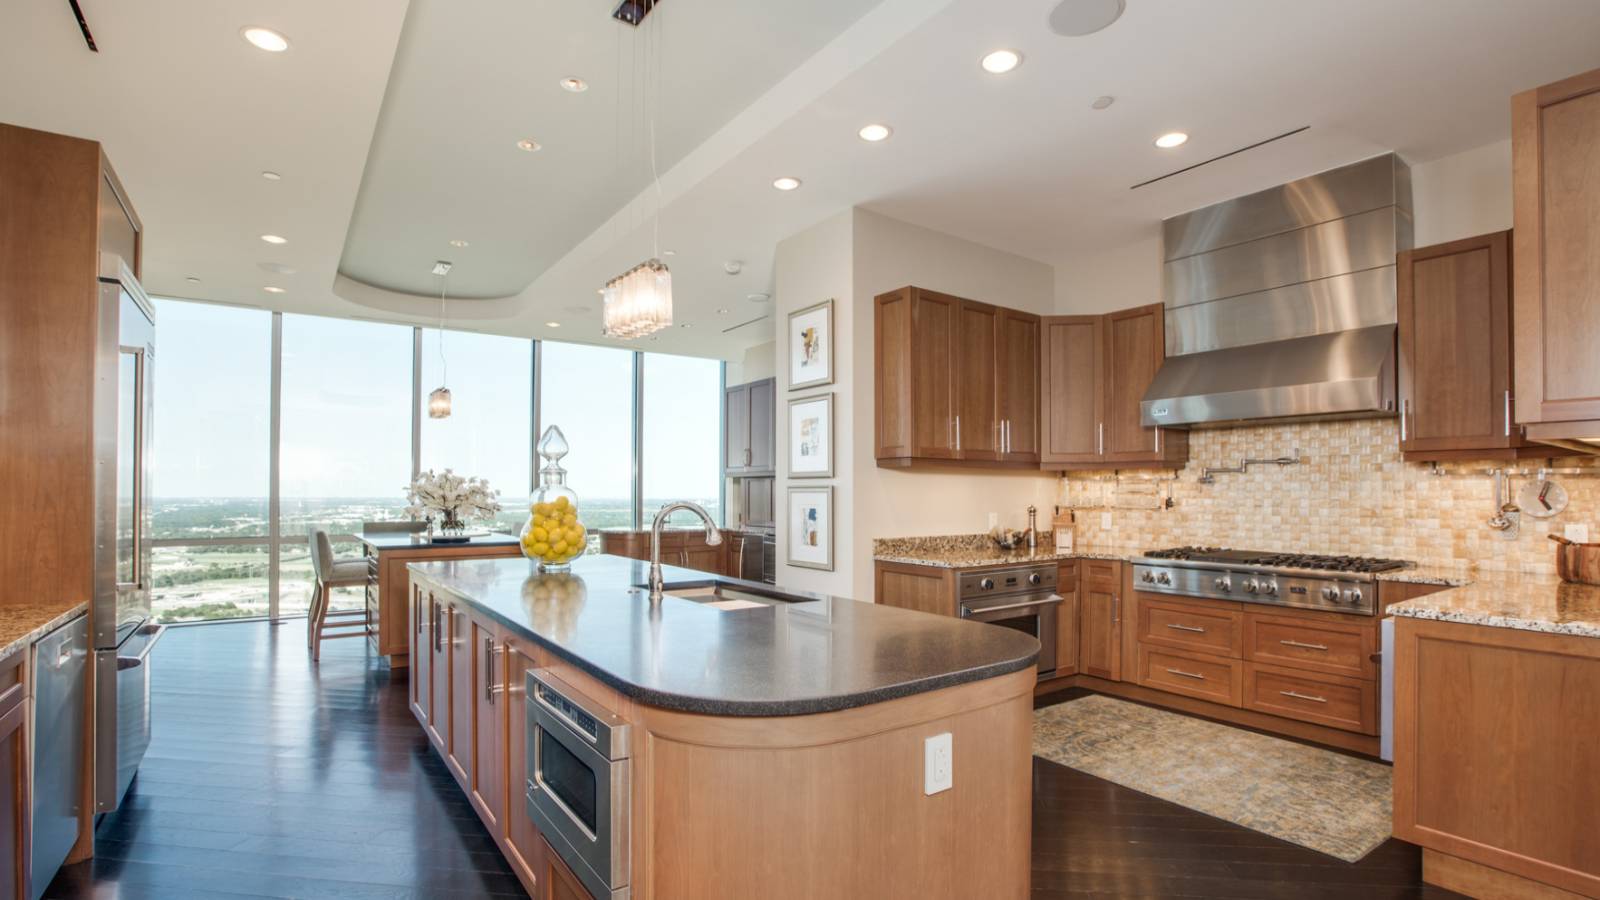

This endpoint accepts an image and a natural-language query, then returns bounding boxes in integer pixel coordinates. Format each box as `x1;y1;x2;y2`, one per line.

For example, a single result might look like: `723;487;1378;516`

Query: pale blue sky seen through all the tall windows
152;299;722;501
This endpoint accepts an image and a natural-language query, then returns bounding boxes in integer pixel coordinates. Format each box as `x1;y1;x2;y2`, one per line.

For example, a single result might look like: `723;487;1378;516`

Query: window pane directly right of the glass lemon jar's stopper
539;341;637;551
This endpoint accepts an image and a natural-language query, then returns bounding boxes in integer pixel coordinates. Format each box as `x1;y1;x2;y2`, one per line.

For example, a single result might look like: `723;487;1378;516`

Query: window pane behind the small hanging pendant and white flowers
419;328;533;533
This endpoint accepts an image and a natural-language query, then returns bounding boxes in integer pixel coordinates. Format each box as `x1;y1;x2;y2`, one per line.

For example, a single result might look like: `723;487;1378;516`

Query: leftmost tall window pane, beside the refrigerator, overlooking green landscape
150;299;272;621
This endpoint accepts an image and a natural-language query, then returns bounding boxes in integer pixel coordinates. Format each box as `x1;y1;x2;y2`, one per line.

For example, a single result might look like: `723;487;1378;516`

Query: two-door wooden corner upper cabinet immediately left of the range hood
1040;303;1189;469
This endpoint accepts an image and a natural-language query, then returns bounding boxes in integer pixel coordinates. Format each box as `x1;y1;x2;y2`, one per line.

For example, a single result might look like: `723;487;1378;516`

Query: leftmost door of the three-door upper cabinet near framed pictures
909;288;962;460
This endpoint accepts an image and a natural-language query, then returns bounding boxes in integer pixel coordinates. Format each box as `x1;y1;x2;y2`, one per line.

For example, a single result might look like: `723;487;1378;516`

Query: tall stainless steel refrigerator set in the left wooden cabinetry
91;253;162;812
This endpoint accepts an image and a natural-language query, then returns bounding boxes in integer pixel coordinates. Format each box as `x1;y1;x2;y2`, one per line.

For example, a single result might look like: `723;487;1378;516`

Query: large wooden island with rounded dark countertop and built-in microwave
410;556;1038;898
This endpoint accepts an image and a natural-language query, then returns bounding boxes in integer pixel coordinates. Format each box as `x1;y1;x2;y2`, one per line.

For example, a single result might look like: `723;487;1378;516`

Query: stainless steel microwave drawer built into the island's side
525;669;632;900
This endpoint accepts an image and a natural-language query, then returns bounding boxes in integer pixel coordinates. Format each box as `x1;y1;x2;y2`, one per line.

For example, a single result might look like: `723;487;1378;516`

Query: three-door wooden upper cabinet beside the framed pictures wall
874;287;1040;466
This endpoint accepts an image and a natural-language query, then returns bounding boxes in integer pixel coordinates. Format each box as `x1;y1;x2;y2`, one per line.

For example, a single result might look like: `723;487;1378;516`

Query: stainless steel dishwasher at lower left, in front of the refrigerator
29;617;90;900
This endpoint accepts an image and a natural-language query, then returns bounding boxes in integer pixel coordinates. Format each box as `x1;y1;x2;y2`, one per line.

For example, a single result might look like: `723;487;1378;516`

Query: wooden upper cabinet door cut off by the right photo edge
1512;69;1600;424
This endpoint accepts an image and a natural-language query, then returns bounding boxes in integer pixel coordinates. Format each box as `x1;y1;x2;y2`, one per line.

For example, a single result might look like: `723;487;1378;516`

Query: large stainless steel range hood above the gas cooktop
1141;154;1411;426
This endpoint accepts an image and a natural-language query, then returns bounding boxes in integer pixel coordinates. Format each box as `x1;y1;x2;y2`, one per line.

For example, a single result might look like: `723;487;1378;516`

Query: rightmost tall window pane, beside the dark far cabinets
640;347;723;524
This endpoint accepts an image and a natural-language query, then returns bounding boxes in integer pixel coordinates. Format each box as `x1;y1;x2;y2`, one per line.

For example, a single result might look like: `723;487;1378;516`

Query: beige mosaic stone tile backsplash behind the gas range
1059;420;1600;573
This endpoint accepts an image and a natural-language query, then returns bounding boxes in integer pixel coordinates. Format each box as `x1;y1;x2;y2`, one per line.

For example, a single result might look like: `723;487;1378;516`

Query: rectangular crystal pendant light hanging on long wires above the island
600;3;672;341
